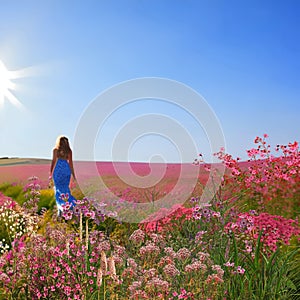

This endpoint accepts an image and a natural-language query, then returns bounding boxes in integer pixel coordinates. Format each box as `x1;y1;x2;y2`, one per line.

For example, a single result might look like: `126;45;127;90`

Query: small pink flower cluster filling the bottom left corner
1;229;116;300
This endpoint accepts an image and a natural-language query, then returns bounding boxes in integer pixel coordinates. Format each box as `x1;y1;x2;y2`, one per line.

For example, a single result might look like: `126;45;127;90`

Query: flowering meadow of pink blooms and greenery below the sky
0;135;300;300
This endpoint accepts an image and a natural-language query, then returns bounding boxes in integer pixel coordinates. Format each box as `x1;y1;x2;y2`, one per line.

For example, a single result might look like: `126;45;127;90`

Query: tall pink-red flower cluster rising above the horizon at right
215;134;300;203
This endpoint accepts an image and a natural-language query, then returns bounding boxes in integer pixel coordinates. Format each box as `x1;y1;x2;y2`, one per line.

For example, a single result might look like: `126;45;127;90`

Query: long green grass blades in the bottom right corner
218;235;299;300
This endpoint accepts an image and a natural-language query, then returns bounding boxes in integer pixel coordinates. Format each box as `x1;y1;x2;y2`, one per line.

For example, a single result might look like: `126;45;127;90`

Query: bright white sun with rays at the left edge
0;60;23;108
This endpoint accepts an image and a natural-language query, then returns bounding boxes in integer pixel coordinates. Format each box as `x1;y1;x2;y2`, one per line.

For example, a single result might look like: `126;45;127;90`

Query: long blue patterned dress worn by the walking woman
53;158;76;215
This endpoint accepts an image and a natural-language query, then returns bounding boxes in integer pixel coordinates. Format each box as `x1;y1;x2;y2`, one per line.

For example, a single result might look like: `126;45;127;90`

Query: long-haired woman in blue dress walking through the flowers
49;136;76;215
